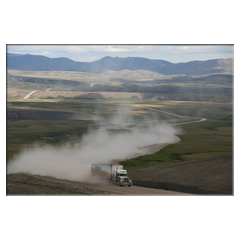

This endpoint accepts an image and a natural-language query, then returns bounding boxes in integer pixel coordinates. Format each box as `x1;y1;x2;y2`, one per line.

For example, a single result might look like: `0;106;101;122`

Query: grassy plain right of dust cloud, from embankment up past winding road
122;101;233;170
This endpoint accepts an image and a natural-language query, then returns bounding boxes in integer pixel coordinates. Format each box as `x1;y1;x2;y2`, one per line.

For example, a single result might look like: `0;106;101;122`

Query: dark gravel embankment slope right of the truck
128;156;233;195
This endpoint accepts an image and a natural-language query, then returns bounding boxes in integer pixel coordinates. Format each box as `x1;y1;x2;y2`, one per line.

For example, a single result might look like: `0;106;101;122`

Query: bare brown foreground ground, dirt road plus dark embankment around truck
7;156;233;196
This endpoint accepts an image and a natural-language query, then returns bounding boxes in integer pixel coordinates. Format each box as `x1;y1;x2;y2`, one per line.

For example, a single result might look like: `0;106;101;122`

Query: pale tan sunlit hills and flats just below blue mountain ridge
7;70;233;102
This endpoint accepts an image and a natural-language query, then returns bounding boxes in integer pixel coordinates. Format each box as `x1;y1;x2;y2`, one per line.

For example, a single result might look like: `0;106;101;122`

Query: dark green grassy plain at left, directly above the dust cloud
7;120;93;162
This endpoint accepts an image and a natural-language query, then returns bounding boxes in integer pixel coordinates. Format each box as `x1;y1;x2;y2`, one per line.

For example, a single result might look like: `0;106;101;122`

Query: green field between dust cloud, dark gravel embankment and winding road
122;119;233;170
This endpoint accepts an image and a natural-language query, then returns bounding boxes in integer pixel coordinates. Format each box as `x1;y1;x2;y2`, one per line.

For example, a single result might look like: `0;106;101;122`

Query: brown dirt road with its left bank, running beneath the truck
7;173;191;196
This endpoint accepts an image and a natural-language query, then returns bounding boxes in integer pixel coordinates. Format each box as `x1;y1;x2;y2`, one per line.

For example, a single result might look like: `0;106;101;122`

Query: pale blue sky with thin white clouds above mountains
7;45;233;63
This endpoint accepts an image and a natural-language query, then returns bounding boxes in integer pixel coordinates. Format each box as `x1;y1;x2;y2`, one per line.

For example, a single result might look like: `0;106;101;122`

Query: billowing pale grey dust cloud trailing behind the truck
7;104;180;182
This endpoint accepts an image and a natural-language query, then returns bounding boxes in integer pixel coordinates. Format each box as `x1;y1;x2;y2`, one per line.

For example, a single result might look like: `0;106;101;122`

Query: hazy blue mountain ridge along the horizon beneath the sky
7;53;233;76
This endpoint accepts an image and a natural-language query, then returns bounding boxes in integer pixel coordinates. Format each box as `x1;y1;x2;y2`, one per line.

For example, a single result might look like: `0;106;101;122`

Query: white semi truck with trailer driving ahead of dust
91;164;132;187
